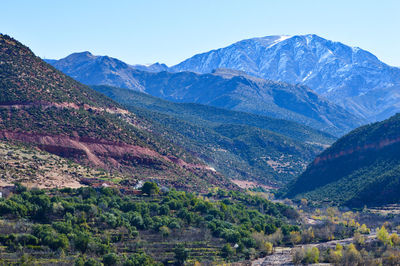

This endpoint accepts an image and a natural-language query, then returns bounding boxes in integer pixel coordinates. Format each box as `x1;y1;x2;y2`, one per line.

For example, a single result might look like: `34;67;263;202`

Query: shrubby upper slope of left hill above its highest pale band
0;34;118;107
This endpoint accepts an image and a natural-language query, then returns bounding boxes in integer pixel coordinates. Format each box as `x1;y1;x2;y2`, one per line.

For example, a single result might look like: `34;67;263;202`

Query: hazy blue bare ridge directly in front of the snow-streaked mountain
127;69;361;135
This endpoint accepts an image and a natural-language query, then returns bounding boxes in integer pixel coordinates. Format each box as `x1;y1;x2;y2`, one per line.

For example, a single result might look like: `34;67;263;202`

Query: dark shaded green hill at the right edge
285;114;400;207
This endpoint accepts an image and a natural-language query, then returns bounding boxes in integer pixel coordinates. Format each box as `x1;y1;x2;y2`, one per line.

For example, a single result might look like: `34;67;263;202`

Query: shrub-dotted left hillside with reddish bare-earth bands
0;35;234;191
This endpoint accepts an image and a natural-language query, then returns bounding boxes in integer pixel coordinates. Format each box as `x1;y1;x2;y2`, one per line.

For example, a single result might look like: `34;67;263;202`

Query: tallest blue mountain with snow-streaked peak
170;34;400;121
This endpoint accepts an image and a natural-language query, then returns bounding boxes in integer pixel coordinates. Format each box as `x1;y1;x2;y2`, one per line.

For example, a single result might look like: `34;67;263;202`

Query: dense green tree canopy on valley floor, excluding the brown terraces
0;183;299;265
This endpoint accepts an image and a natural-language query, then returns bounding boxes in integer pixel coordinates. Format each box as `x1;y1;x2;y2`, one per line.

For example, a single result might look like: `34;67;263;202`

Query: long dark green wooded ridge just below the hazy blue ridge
92;86;335;145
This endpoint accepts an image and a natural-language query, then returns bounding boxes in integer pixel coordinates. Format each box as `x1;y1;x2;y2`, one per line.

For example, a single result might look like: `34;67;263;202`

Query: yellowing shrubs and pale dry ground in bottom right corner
290;203;400;266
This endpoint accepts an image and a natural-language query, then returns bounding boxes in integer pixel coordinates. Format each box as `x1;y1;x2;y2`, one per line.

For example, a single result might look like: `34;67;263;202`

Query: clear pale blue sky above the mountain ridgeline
0;0;400;66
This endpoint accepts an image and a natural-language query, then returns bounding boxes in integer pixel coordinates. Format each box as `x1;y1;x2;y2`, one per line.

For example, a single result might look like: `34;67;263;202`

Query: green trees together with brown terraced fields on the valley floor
0;183;299;265
